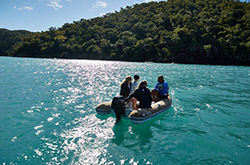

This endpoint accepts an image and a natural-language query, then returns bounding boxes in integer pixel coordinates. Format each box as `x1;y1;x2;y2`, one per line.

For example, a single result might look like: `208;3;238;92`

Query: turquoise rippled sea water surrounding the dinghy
0;57;250;164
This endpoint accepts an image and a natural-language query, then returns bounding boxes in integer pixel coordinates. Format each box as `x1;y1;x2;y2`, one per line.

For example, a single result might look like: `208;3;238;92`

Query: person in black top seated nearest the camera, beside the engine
125;80;152;110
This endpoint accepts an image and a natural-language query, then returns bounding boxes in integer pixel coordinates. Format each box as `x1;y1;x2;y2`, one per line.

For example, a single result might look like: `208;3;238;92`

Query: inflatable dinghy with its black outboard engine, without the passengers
96;96;172;123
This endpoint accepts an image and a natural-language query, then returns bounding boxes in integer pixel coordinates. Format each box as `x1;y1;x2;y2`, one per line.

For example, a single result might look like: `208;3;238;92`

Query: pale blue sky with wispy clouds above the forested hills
0;0;162;32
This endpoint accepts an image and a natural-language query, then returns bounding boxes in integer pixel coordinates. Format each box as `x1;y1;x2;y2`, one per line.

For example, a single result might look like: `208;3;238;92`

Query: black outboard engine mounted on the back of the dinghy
111;96;125;121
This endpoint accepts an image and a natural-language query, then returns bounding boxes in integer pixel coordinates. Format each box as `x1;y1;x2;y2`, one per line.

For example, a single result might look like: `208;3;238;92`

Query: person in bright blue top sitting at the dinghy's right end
154;76;169;100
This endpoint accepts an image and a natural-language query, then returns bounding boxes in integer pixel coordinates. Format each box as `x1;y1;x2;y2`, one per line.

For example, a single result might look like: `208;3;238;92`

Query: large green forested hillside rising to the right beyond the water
0;0;250;65
